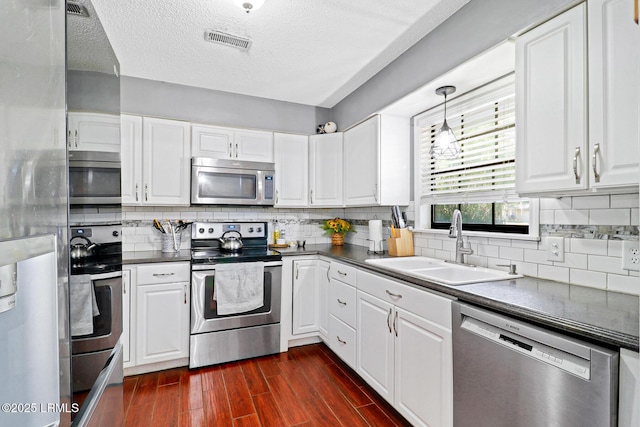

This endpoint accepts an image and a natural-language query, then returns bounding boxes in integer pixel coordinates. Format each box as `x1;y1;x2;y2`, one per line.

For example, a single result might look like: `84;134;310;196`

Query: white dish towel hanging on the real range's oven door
213;262;264;315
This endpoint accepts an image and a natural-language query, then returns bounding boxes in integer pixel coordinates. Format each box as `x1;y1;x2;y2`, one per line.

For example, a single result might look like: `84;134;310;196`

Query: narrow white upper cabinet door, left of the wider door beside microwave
121;115;142;205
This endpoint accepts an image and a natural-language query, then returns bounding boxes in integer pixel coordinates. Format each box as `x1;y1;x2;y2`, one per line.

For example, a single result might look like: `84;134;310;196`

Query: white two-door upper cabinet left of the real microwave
122;115;191;206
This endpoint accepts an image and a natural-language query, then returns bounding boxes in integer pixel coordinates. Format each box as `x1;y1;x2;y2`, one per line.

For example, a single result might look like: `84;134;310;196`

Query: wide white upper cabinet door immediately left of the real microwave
142;117;191;206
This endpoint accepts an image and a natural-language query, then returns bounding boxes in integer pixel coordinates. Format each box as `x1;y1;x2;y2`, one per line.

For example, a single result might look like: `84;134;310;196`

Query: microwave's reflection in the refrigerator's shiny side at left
69;151;122;205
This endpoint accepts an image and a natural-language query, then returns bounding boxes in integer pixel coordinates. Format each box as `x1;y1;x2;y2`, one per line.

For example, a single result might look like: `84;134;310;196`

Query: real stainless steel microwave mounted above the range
191;157;275;206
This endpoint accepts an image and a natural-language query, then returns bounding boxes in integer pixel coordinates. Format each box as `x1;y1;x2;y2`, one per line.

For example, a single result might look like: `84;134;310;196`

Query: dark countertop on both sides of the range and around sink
123;244;639;351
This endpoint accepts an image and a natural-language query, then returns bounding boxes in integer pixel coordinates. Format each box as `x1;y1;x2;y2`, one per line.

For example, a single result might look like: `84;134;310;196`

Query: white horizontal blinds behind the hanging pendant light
416;74;516;204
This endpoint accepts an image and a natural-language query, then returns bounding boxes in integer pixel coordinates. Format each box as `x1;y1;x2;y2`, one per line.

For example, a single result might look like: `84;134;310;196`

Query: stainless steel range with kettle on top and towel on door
189;222;282;368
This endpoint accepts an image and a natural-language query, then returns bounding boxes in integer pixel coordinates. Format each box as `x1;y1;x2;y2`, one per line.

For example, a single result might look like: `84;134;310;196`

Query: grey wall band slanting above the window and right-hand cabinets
331;0;575;129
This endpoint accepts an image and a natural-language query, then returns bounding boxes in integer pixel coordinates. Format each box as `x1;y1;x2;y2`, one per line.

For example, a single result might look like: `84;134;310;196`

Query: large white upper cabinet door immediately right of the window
516;4;589;194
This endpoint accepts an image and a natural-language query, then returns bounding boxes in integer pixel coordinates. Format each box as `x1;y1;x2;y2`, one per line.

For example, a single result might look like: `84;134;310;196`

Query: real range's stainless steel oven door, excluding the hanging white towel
191;261;282;334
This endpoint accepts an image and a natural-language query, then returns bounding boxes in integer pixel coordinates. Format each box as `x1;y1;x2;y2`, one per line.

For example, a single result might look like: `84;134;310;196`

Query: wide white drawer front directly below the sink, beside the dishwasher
358;270;451;329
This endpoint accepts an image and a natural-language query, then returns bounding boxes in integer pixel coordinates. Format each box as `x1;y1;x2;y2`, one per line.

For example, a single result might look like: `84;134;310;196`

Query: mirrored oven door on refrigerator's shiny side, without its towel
71;271;122;354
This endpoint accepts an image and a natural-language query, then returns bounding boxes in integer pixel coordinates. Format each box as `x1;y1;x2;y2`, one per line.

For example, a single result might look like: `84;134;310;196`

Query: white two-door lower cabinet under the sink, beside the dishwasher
356;270;453;426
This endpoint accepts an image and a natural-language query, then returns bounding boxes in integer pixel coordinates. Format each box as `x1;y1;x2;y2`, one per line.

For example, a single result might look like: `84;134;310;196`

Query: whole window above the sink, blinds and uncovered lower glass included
415;74;531;239
